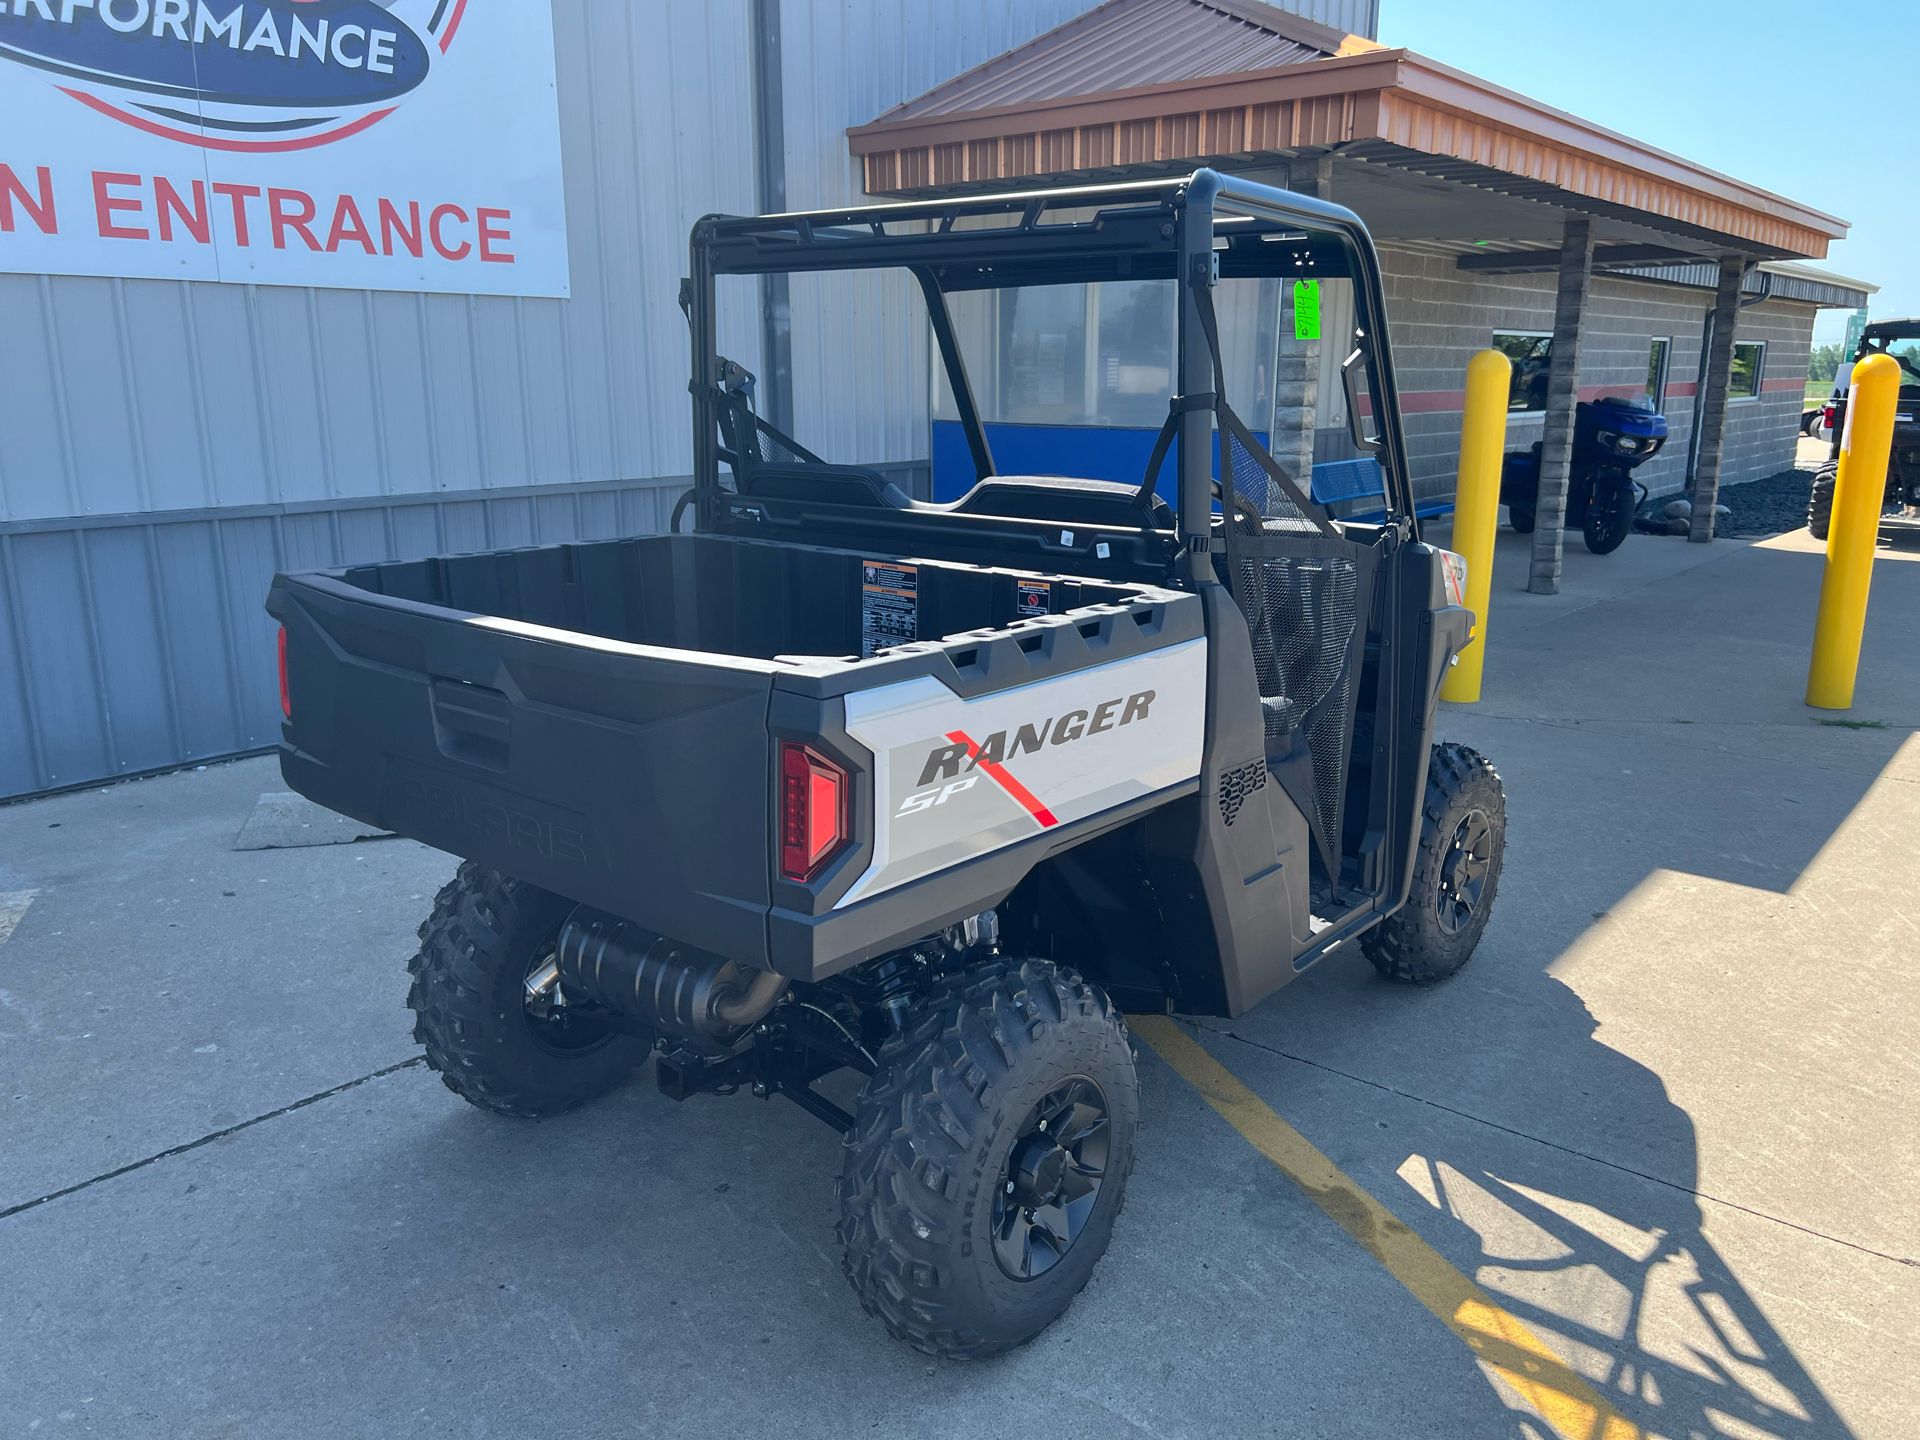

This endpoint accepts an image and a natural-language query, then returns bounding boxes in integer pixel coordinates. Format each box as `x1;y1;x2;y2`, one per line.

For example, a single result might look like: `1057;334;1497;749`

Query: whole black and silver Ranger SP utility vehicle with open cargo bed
267;169;1505;1357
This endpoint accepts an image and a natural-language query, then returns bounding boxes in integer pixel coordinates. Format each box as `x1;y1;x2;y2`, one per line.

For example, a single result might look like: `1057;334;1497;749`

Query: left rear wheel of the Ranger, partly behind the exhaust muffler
407;860;647;1117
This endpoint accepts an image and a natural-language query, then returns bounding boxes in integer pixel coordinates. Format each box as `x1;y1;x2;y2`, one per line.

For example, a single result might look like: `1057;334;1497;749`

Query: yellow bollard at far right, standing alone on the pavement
1807;355;1901;710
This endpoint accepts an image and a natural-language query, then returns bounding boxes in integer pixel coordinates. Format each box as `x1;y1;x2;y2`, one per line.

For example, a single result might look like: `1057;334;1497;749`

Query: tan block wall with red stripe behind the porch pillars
1380;246;1814;514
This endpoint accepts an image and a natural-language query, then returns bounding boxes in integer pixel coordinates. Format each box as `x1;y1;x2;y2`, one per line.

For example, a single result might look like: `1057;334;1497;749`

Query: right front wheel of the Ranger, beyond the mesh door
1359;745;1507;985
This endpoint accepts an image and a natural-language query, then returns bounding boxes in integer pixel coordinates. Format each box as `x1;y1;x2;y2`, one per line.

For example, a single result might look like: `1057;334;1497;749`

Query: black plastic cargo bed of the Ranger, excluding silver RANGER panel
267;536;1200;977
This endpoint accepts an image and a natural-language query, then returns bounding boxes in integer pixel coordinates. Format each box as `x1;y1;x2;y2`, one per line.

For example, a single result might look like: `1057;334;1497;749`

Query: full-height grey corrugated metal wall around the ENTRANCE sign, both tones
0;0;758;797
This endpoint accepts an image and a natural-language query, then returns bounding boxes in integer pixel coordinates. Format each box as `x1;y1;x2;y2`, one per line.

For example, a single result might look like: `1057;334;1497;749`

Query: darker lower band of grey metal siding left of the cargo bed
0;480;685;799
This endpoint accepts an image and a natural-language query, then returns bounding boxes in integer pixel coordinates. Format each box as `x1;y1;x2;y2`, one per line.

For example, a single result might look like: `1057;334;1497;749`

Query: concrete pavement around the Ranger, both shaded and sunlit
0;536;1920;1440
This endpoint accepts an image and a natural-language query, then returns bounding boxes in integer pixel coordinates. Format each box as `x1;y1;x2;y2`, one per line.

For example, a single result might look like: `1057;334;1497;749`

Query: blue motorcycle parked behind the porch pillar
1500;396;1667;555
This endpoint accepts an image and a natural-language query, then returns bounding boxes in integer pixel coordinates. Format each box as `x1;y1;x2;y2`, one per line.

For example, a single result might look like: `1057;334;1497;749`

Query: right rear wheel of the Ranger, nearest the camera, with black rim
839;958;1140;1359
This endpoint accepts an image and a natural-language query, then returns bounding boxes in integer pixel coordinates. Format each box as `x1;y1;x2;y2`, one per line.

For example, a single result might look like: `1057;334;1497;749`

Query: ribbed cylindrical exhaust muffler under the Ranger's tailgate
555;904;789;1054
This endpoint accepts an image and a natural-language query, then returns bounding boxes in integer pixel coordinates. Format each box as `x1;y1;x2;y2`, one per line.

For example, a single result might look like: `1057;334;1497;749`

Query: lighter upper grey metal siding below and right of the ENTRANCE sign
0;0;764;520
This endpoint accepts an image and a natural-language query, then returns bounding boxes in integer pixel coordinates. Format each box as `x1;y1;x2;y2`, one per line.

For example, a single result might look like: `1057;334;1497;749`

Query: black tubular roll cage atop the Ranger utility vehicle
682;169;1419;584
